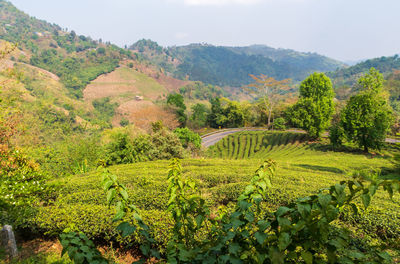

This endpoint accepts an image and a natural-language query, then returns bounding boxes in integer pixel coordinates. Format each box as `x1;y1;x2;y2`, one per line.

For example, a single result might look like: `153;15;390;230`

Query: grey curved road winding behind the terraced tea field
201;127;400;148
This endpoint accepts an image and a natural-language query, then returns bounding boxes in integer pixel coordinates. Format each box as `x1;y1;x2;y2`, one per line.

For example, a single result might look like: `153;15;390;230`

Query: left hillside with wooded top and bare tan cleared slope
0;0;195;131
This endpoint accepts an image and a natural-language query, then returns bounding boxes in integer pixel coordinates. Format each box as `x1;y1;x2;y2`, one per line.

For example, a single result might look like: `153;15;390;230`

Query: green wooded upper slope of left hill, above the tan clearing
0;0;131;98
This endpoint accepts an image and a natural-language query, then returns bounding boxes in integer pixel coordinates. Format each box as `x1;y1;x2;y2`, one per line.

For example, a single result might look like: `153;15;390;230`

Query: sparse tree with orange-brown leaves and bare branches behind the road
247;74;290;127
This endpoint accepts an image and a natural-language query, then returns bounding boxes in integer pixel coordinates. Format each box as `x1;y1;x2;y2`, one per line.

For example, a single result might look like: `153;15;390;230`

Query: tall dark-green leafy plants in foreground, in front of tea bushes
58;160;400;263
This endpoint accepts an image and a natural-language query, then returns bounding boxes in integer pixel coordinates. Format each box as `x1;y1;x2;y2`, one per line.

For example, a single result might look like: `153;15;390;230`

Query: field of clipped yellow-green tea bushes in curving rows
29;131;400;255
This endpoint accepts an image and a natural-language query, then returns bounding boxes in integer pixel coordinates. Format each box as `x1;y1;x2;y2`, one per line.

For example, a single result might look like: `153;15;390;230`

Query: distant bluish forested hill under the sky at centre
130;40;344;87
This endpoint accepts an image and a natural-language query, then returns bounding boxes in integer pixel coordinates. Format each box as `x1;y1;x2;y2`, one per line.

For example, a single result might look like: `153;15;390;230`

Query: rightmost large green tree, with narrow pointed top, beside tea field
340;68;393;152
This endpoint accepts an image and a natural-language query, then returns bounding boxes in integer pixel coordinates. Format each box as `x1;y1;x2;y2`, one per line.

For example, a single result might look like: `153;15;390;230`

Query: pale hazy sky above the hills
6;0;400;60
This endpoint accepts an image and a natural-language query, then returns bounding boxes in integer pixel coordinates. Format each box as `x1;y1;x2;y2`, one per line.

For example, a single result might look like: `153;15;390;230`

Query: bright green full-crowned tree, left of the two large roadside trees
288;73;334;138
